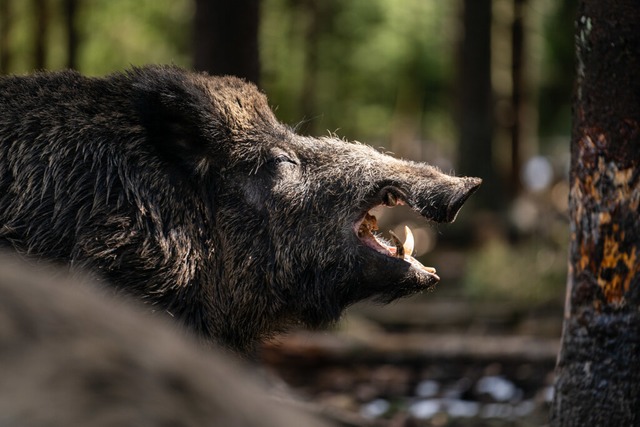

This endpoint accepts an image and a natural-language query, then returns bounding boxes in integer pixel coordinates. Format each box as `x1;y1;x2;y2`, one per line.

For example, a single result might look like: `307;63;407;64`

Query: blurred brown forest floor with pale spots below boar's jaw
262;290;562;427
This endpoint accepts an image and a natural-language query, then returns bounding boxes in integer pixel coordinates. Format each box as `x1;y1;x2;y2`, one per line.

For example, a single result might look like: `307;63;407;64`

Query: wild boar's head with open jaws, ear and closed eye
132;65;481;350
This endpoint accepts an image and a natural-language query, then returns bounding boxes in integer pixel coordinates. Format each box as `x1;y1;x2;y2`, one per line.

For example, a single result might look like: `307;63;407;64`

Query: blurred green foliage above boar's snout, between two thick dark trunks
261;0;455;145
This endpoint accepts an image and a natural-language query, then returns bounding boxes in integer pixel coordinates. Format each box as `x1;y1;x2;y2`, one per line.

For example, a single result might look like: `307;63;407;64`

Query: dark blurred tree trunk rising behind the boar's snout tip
457;0;501;210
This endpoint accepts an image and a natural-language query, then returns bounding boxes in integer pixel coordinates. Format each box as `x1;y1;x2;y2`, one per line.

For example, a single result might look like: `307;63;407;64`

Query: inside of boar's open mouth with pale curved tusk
354;193;440;280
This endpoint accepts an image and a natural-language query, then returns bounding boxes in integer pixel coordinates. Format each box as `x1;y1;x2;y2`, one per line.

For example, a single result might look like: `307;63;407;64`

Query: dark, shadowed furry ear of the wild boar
134;68;216;168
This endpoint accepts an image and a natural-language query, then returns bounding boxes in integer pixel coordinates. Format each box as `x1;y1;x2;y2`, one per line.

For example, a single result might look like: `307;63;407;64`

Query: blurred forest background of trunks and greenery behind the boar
0;0;577;424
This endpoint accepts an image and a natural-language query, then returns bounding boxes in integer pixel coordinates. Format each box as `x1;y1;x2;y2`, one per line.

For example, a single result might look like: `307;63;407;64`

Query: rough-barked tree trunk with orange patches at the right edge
551;0;640;426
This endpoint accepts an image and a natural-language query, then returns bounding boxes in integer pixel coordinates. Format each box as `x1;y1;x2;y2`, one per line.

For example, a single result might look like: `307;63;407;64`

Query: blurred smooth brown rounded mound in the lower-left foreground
0;254;324;427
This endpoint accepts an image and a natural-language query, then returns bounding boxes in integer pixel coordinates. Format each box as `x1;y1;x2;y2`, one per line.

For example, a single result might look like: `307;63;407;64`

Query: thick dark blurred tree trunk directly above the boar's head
193;0;260;84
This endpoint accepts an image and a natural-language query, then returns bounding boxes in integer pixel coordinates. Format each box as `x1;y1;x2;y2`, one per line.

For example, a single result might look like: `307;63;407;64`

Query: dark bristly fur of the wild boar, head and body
0;66;479;351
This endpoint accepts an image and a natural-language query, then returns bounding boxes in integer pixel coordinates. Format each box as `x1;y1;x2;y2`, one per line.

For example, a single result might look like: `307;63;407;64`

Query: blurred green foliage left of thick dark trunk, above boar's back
3;0;193;75
